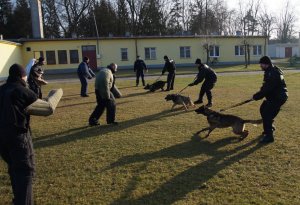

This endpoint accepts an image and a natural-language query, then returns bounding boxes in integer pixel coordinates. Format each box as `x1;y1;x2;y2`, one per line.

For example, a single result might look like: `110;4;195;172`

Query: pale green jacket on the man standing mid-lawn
95;68;114;99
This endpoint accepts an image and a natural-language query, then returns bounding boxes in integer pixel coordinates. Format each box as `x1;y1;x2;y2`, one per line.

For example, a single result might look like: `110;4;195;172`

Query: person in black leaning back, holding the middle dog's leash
189;58;217;107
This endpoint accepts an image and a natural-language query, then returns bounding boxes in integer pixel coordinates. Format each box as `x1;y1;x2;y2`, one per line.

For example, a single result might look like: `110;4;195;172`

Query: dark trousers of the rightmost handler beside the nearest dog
260;100;286;136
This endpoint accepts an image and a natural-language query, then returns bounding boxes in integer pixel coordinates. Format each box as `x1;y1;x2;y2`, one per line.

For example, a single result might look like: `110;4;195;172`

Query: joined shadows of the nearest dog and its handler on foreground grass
111;137;263;205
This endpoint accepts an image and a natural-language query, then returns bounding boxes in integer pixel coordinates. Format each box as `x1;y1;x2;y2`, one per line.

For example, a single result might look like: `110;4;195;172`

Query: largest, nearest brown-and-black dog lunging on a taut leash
195;105;262;139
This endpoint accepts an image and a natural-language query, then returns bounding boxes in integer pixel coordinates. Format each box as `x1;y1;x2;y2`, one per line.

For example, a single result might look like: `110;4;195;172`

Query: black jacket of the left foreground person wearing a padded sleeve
0;78;37;133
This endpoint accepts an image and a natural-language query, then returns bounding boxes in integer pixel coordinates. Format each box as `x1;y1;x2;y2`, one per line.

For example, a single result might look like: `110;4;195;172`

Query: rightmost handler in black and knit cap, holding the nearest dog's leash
252;56;288;143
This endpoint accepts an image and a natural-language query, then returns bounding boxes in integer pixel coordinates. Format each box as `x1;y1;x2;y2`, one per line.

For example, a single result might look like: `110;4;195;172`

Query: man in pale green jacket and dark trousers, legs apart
89;63;118;126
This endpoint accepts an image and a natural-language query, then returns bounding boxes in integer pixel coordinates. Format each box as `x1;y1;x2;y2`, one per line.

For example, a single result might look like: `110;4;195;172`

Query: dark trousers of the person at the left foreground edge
0;132;35;205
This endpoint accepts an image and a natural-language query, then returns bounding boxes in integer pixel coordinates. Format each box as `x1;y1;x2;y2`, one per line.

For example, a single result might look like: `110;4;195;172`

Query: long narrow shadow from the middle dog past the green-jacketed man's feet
34;109;193;148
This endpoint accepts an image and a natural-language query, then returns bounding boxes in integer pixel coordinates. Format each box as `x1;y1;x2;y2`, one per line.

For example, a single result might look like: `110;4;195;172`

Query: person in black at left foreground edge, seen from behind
0;64;38;205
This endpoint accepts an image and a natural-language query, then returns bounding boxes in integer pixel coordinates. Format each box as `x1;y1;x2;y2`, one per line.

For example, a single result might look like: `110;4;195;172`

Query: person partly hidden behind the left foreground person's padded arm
28;57;48;99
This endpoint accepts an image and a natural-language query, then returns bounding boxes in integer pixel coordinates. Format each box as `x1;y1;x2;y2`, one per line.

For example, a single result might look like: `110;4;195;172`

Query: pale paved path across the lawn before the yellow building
46;69;300;83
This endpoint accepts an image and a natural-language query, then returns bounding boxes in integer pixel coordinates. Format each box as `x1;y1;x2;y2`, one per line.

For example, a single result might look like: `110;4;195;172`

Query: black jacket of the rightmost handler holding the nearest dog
253;66;288;101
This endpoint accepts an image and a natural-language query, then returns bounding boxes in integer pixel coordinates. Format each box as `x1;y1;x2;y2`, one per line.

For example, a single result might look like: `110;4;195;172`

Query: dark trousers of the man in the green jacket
89;90;116;124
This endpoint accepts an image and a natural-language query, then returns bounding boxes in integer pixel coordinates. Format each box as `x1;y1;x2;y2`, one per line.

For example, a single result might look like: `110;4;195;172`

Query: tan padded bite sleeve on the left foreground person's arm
26;88;63;116
